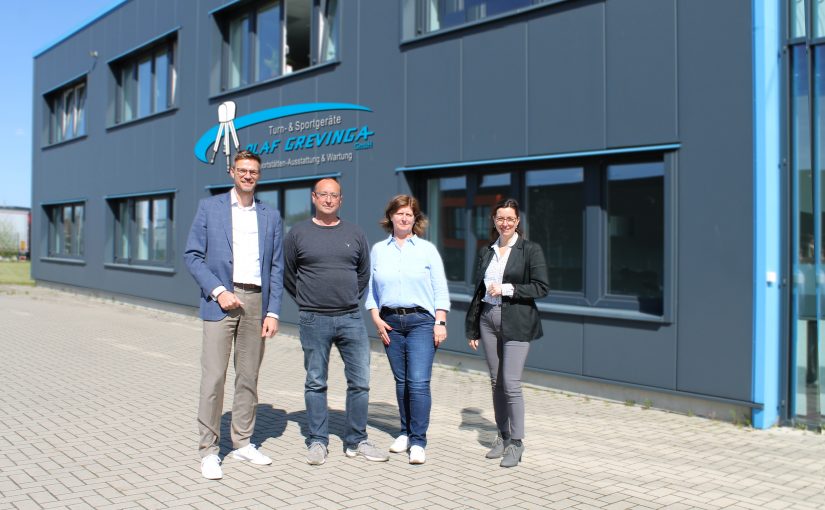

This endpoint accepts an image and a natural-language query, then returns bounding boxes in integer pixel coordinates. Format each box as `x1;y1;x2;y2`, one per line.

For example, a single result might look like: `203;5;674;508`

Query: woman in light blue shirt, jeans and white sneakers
366;195;450;464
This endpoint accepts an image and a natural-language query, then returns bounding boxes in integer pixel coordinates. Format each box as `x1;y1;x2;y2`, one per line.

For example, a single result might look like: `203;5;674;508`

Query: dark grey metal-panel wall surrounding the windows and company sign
32;0;753;406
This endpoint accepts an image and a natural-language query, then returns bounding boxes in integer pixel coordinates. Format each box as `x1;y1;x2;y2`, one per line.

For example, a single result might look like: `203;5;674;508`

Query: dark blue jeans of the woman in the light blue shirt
383;313;435;448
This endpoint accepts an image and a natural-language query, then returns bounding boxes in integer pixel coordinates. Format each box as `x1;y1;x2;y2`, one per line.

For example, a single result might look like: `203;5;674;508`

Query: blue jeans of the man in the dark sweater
299;312;370;448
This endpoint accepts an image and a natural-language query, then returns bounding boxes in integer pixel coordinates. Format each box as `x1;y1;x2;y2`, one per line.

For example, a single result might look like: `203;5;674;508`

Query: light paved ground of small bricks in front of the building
0;287;825;509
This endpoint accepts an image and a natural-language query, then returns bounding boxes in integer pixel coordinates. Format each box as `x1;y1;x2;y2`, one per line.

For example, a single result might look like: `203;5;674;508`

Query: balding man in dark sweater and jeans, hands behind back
284;178;389;465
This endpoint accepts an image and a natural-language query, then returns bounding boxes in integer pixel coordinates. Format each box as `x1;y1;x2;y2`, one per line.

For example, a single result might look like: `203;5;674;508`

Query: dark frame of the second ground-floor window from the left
106;191;176;268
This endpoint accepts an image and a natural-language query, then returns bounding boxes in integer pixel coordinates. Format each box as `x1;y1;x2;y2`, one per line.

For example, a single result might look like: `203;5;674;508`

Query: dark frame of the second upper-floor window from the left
109;27;179;127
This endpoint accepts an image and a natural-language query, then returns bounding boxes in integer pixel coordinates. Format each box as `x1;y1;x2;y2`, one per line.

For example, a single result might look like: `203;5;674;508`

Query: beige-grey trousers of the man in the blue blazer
198;288;265;457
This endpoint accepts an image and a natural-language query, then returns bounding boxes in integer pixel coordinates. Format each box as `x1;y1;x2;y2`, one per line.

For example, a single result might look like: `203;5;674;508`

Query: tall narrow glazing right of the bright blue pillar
787;0;825;424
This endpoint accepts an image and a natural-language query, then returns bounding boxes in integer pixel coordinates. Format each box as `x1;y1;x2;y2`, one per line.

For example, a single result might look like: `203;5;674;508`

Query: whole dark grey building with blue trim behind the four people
32;0;825;427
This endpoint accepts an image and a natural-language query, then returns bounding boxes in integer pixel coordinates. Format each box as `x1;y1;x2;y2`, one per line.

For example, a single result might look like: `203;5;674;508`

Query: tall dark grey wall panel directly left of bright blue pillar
677;0;754;399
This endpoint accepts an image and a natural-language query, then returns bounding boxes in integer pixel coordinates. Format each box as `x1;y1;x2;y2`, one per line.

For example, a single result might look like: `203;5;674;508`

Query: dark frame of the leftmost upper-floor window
43;79;89;146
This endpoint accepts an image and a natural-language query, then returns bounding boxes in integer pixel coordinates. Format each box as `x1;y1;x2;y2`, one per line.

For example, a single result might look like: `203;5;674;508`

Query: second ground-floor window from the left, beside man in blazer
109;195;173;265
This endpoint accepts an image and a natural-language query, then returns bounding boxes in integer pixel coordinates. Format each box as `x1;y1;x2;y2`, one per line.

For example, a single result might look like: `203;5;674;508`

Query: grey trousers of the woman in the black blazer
480;303;530;439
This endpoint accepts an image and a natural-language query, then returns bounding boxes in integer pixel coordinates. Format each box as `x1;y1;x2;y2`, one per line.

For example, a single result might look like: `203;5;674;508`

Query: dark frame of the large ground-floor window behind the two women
416;150;677;323
